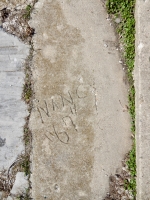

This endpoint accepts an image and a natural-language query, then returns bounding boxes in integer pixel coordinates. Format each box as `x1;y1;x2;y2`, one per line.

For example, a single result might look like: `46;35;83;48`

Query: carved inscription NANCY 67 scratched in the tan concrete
36;85;97;144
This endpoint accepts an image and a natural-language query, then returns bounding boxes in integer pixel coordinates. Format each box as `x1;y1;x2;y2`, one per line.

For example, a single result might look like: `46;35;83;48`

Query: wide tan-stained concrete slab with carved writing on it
30;0;131;200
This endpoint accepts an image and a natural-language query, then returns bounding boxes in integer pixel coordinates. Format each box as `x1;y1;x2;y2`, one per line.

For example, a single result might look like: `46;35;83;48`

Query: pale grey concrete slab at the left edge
0;30;29;171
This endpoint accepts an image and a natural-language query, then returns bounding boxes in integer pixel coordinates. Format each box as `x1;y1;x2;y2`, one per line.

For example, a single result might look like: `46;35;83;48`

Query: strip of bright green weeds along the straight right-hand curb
106;0;136;199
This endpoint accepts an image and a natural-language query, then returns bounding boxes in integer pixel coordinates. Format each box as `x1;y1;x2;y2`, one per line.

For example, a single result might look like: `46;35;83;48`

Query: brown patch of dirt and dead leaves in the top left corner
0;0;36;43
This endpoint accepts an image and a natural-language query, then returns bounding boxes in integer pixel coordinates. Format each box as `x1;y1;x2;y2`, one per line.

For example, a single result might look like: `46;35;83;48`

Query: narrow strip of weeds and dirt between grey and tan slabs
18;46;33;200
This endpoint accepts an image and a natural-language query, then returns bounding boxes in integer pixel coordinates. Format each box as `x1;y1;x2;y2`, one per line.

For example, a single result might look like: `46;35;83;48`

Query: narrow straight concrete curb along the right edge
134;0;150;200
